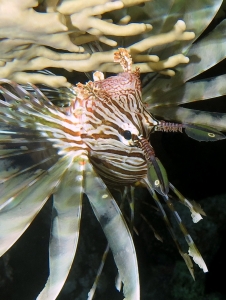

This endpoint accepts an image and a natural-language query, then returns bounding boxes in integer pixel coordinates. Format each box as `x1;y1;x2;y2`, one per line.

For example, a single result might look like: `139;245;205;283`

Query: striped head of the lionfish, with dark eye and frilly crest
75;48;157;186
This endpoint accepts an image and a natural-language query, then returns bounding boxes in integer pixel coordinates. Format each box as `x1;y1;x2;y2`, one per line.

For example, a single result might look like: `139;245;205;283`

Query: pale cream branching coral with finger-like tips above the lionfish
0;0;194;87
